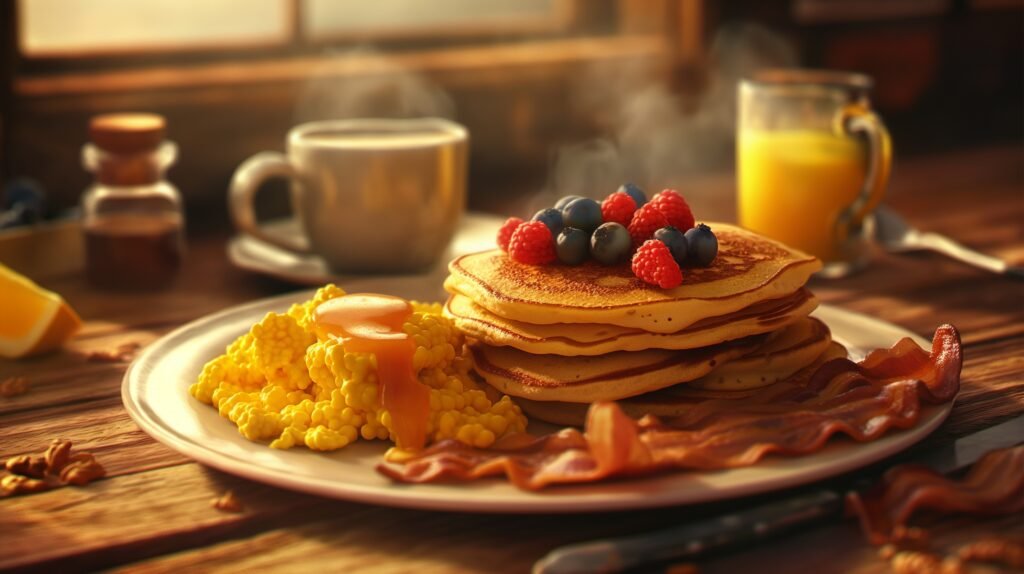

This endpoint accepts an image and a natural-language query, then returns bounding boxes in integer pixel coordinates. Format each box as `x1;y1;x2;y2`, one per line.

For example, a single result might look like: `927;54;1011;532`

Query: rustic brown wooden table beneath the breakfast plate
0;148;1024;572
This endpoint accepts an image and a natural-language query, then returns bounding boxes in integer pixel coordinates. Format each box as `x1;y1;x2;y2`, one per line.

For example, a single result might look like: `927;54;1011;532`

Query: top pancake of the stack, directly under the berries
444;223;821;334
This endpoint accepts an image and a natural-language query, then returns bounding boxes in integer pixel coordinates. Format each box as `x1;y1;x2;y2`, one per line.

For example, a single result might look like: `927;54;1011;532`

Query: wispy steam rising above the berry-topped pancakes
530;24;797;214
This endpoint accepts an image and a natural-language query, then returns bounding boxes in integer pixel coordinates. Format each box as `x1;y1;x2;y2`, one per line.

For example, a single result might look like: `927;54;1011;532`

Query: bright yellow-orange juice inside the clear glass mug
737;129;866;263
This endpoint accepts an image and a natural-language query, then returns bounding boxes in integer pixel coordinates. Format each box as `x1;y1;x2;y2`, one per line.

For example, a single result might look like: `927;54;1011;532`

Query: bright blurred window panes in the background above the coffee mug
18;0;578;58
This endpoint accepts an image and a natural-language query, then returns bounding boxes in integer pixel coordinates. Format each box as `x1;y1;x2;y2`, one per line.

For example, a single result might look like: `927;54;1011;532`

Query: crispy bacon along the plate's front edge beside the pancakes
378;325;963;490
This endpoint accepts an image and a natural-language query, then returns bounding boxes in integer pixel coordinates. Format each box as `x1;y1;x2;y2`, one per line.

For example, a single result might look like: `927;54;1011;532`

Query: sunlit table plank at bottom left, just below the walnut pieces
0;463;343;572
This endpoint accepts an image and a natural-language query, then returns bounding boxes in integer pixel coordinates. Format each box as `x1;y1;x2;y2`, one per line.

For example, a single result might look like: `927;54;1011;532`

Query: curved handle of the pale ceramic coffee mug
227;151;310;253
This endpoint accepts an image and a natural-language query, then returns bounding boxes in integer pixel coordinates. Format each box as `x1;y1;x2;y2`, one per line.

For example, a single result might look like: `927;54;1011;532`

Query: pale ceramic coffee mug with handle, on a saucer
229;118;468;272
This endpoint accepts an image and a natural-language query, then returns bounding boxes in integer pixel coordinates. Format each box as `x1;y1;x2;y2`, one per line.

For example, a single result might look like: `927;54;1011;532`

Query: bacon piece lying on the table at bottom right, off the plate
846;445;1024;544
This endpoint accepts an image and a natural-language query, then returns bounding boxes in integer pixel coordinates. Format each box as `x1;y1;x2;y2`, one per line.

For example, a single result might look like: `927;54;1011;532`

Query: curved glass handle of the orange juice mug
836;103;893;245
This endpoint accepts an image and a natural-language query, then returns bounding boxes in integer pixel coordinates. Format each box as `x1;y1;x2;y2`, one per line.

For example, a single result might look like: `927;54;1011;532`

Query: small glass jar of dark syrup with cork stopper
82;114;184;290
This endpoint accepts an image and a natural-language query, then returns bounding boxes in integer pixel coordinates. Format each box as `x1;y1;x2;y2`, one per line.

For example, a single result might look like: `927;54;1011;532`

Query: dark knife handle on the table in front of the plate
534;489;843;574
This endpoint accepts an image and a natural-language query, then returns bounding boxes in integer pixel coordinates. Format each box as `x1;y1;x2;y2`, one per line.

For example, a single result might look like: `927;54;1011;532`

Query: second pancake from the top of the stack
444;289;818;356
